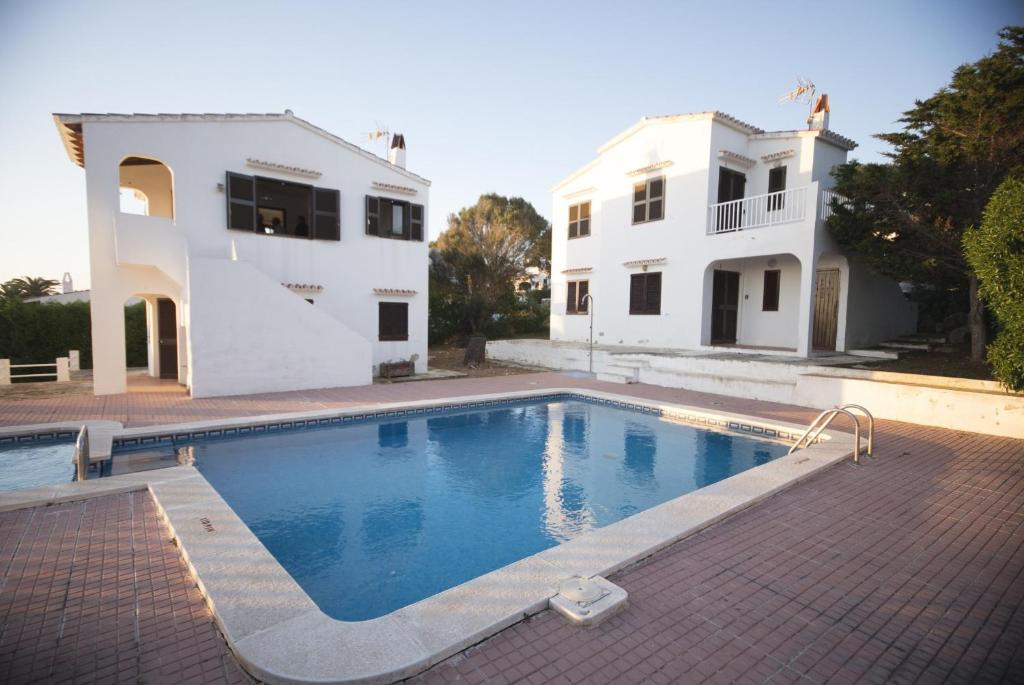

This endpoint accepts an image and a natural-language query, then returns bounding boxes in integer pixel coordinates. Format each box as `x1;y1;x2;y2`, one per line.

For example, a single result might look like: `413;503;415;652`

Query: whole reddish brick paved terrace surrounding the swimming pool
0;374;1024;683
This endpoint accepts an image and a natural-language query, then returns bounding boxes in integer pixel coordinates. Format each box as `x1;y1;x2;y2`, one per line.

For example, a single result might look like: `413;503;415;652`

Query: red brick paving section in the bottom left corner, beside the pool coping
0;493;252;683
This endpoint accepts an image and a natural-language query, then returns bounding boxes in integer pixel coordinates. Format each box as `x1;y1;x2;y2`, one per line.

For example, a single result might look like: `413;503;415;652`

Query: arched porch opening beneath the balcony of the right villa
700;254;801;352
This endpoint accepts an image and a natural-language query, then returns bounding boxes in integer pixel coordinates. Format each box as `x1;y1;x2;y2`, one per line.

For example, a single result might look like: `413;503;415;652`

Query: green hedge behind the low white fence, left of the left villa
0;299;146;369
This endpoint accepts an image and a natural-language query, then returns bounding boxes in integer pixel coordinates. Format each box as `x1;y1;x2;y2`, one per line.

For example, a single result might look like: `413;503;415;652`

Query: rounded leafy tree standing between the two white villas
430;195;551;340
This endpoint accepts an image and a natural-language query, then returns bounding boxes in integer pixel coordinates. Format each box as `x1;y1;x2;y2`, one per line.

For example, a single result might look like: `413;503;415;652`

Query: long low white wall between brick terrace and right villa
487;340;1024;438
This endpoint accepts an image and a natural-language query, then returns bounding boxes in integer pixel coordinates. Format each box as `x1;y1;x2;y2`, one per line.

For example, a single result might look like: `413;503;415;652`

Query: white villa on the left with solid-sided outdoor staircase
54;111;430;397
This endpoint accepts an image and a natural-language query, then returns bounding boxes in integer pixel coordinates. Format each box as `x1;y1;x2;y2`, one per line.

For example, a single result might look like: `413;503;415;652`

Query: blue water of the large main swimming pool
123;399;786;620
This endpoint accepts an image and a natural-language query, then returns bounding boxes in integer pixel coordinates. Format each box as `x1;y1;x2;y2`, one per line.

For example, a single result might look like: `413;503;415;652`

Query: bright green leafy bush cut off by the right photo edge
964;176;1024;391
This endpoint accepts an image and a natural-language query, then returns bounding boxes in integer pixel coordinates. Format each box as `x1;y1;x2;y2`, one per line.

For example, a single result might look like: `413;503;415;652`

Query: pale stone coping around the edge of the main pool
0;387;863;683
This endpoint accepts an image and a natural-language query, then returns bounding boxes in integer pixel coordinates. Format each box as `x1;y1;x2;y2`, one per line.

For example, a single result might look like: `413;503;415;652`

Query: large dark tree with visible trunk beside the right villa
828;27;1024;359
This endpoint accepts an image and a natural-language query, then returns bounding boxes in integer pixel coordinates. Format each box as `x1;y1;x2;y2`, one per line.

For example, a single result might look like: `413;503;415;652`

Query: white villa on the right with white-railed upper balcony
551;101;916;356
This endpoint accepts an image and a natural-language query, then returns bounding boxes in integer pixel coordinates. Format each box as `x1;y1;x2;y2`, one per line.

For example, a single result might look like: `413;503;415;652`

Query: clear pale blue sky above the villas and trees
0;0;1024;288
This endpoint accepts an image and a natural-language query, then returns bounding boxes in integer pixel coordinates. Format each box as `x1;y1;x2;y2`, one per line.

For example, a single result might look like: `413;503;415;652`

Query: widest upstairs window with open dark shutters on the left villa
225;171;341;241
